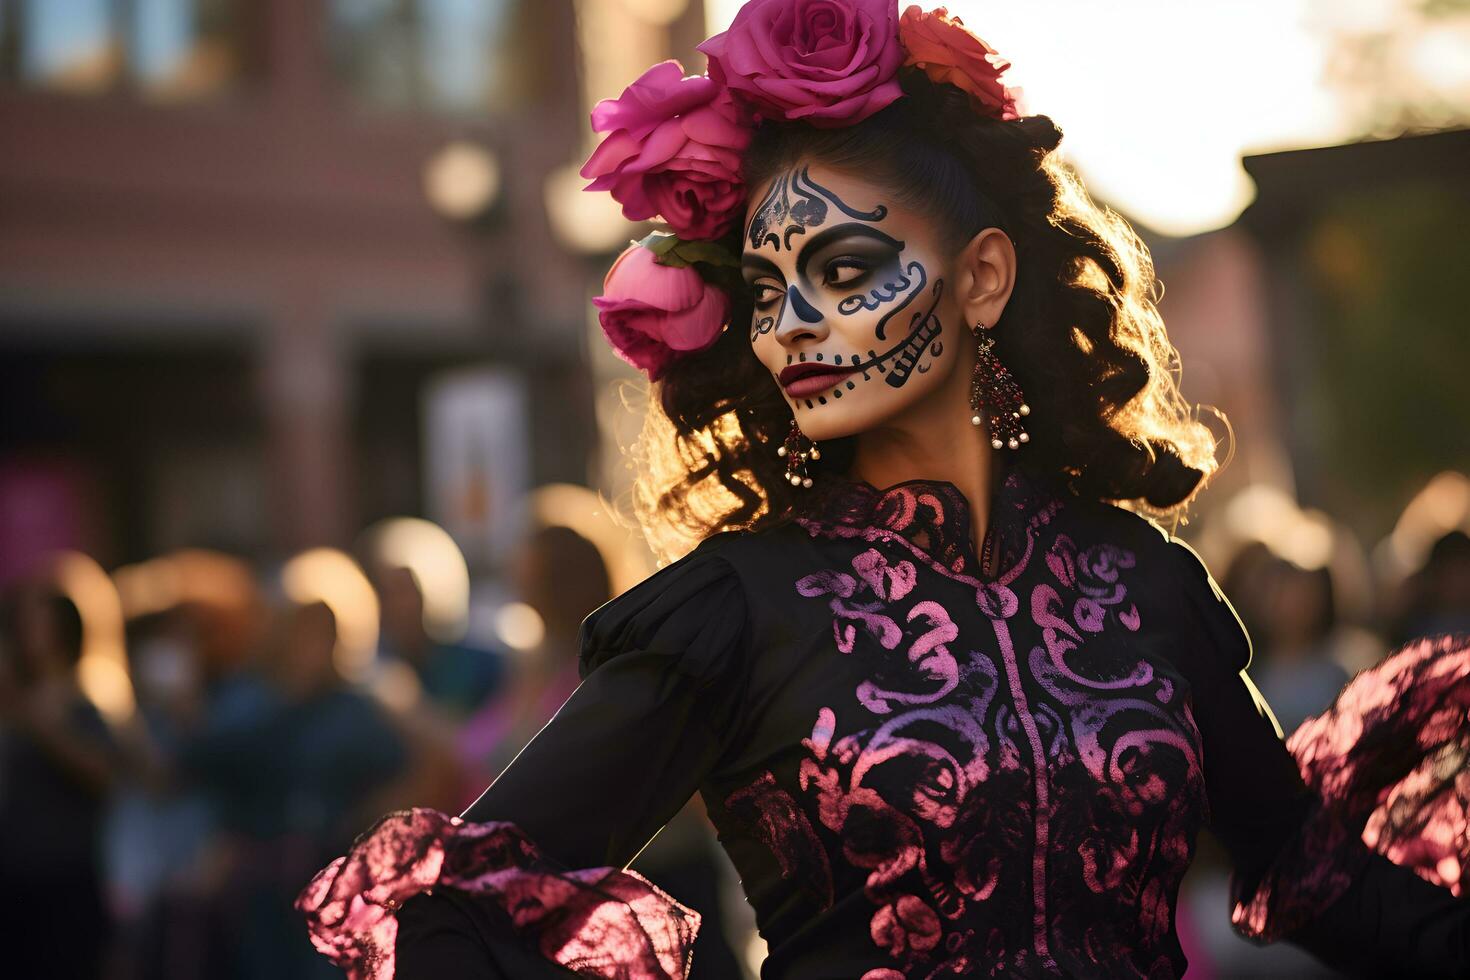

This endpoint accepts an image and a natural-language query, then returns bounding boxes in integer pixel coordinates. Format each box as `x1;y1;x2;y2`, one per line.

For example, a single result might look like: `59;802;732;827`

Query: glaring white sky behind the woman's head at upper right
707;0;1417;235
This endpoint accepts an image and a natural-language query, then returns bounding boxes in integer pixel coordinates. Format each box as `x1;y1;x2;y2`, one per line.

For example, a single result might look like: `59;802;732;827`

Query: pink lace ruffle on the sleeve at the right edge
1230;636;1470;942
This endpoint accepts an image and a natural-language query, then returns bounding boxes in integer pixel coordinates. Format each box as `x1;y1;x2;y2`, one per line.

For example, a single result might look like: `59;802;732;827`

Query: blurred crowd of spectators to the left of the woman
0;522;741;980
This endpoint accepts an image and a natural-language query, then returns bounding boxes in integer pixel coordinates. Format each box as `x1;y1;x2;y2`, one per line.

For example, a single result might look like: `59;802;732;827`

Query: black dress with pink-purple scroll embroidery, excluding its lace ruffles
400;467;1470;980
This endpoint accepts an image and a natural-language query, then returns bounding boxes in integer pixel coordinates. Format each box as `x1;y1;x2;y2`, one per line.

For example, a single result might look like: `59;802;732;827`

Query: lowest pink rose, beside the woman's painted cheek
592;245;731;381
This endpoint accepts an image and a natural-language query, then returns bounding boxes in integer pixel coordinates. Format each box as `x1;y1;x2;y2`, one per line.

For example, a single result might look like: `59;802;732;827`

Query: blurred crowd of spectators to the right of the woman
1177;472;1470;980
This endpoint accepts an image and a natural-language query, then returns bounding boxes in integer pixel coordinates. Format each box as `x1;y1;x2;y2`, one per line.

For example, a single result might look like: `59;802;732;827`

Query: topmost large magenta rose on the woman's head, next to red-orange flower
700;0;904;128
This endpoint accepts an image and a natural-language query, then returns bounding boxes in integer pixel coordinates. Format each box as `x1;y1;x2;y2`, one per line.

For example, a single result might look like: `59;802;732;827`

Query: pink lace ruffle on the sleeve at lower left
295;808;700;980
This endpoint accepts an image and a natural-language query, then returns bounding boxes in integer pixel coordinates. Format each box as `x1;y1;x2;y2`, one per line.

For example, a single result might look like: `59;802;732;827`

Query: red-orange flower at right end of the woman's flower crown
898;6;1022;119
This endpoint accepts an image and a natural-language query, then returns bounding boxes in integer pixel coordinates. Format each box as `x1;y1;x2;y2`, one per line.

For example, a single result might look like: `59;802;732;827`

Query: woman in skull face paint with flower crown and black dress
300;0;1470;980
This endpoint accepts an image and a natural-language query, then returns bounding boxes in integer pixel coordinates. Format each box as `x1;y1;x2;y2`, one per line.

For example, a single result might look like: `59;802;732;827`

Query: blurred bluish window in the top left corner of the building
0;0;240;101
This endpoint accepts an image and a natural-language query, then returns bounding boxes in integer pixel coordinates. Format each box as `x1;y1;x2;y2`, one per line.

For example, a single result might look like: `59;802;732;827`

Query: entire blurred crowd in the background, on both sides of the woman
0;473;1470;980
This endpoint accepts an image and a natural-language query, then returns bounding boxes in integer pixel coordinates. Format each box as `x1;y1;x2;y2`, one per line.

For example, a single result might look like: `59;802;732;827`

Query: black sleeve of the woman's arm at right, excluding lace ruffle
1166;539;1470;977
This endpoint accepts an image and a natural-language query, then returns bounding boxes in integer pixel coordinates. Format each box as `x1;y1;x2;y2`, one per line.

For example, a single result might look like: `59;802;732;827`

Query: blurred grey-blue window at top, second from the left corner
328;0;528;113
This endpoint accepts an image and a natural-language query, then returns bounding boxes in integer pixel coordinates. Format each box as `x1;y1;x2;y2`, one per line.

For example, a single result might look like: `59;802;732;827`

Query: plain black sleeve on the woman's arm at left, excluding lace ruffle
397;542;748;980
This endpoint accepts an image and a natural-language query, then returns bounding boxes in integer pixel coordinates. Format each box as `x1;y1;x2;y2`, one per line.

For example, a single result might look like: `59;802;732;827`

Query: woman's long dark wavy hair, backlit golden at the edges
632;68;1223;557
